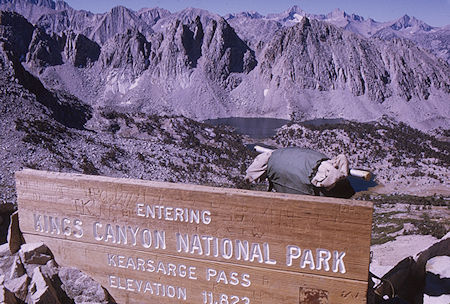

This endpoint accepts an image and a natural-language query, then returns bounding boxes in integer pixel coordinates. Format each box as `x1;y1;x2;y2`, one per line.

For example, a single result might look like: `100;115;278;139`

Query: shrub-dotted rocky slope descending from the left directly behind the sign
0;47;251;205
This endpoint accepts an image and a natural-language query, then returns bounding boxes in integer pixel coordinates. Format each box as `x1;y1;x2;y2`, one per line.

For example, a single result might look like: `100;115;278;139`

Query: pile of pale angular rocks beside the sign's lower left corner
0;214;115;304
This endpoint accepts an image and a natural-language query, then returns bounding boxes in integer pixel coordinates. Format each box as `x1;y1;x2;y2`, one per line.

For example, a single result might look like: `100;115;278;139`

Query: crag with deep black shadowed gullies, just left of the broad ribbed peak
149;16;256;88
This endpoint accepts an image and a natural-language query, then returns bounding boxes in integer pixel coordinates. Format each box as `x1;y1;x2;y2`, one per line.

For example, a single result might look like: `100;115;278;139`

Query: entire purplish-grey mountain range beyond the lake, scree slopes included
0;0;450;130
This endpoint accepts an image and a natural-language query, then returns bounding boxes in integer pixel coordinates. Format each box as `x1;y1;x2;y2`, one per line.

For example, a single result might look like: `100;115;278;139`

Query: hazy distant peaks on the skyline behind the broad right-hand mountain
230;6;450;62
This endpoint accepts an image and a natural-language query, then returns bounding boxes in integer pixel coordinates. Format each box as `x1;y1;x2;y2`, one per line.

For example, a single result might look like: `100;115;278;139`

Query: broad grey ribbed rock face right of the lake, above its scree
259;18;450;102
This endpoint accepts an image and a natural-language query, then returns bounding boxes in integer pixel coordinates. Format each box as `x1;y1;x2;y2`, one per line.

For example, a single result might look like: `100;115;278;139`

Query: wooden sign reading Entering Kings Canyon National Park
16;169;372;304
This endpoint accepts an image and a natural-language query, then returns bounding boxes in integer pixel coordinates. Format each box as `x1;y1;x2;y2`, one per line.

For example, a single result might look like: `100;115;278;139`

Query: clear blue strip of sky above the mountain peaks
66;0;450;26
